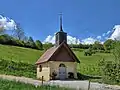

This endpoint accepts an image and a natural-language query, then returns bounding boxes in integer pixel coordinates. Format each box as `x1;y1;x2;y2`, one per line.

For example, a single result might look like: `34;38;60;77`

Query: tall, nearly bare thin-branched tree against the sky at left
13;23;25;40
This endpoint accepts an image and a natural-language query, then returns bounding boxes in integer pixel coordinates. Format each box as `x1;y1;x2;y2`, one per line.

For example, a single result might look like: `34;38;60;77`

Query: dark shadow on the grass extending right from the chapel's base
77;73;102;80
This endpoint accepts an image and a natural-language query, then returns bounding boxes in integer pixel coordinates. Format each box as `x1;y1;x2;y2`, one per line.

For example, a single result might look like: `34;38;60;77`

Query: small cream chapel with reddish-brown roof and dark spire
36;15;80;81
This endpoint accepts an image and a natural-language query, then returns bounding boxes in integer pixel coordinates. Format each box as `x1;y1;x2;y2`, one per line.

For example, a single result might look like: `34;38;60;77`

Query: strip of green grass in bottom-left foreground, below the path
0;79;72;90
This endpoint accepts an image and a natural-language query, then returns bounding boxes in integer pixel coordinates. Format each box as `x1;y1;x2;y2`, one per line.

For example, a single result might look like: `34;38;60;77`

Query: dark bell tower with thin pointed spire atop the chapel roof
55;14;67;46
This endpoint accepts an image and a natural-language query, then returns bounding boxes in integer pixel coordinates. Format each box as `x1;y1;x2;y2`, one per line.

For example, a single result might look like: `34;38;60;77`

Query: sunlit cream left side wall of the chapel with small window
37;63;50;81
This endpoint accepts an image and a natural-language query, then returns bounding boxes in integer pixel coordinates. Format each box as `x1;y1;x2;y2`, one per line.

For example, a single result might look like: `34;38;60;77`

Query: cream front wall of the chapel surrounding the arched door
49;61;77;79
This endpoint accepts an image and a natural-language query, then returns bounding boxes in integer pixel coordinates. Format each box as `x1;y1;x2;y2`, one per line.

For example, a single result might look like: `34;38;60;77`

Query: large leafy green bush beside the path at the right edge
99;59;120;84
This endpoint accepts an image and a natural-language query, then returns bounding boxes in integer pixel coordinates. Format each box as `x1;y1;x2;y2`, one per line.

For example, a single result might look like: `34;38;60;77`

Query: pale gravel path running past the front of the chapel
0;75;120;90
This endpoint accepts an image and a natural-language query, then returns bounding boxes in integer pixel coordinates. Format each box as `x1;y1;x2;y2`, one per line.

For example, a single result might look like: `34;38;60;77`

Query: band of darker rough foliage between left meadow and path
0;60;36;78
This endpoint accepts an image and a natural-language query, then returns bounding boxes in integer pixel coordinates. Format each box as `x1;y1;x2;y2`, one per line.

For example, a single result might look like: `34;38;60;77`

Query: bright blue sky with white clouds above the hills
0;0;120;43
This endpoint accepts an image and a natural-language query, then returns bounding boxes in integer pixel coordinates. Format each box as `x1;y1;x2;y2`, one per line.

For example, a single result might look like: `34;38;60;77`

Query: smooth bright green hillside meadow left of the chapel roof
0;45;43;64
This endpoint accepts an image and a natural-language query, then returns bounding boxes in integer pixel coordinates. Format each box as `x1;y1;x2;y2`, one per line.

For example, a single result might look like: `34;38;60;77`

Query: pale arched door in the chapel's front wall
59;63;66;80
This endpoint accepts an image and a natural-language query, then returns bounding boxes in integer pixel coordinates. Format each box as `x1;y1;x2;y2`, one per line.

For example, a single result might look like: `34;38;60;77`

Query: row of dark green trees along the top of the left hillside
0;34;43;49
